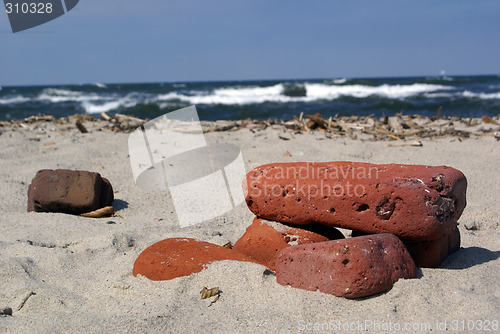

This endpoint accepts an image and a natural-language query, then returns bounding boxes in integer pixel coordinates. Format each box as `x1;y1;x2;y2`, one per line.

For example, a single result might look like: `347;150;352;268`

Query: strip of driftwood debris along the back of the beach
0;109;500;141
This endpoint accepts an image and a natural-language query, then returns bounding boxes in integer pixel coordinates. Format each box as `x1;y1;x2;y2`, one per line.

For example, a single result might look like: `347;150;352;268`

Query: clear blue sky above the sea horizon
0;0;500;86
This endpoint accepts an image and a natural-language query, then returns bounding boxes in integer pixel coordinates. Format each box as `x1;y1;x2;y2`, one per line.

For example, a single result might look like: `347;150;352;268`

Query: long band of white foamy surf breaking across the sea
0;83;500;114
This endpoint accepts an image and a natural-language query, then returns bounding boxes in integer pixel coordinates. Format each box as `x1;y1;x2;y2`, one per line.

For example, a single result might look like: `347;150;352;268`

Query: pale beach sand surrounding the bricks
0;120;500;333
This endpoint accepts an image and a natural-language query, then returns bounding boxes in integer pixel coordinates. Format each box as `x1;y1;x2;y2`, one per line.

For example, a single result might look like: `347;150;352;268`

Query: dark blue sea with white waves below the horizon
0;75;500;120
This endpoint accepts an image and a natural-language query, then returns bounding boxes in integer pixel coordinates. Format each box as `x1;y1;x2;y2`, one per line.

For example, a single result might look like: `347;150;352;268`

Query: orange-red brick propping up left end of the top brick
233;218;344;271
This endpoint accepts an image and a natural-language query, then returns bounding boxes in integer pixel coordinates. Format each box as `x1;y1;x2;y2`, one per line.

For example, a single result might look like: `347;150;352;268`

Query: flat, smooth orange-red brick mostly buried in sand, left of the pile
132;238;255;281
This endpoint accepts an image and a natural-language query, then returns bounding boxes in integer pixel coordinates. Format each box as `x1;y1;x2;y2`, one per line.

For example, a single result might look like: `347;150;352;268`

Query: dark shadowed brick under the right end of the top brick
352;227;460;268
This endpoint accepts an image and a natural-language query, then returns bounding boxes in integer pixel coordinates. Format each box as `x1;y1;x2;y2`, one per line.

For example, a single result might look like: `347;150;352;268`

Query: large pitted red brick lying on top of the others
243;162;467;240
